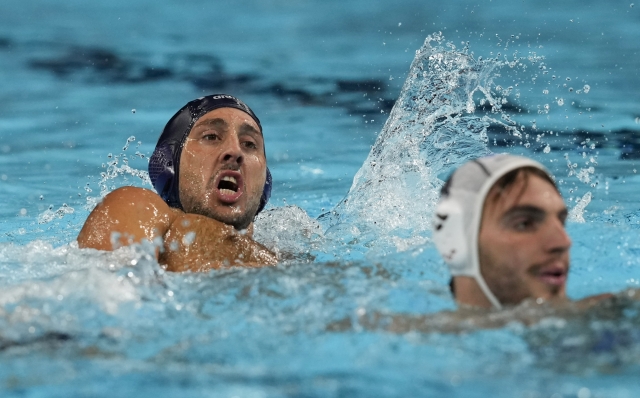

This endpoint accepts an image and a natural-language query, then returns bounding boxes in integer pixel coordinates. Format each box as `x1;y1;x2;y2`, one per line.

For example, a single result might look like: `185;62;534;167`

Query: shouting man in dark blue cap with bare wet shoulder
78;94;277;271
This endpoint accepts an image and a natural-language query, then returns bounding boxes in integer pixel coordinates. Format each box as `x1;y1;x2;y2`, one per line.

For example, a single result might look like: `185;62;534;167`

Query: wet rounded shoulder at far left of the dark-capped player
78;187;180;250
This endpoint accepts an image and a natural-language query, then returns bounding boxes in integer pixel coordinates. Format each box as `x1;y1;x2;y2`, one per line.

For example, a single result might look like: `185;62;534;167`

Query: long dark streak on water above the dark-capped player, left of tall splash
27;45;395;118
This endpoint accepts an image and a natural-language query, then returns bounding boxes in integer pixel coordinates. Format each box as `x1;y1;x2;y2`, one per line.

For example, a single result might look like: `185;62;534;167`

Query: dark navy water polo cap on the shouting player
149;94;272;214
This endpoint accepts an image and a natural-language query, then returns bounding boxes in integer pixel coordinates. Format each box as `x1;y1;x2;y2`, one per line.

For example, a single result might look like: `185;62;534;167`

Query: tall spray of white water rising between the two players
320;33;520;246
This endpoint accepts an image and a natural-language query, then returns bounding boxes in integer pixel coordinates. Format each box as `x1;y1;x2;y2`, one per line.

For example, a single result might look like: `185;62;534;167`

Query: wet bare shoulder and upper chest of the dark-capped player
78;187;277;271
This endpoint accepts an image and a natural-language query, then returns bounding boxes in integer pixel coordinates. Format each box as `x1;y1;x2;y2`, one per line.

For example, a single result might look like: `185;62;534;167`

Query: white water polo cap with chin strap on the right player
432;155;552;309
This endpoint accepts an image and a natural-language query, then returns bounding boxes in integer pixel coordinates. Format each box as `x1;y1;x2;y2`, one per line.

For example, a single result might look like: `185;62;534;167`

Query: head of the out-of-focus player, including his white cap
433;155;571;309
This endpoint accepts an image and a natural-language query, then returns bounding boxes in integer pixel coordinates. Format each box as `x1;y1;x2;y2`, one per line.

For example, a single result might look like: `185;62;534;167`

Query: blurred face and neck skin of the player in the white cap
455;173;571;308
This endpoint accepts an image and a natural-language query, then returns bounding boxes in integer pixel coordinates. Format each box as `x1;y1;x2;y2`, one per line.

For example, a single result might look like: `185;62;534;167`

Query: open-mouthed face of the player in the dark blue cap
180;108;267;229
